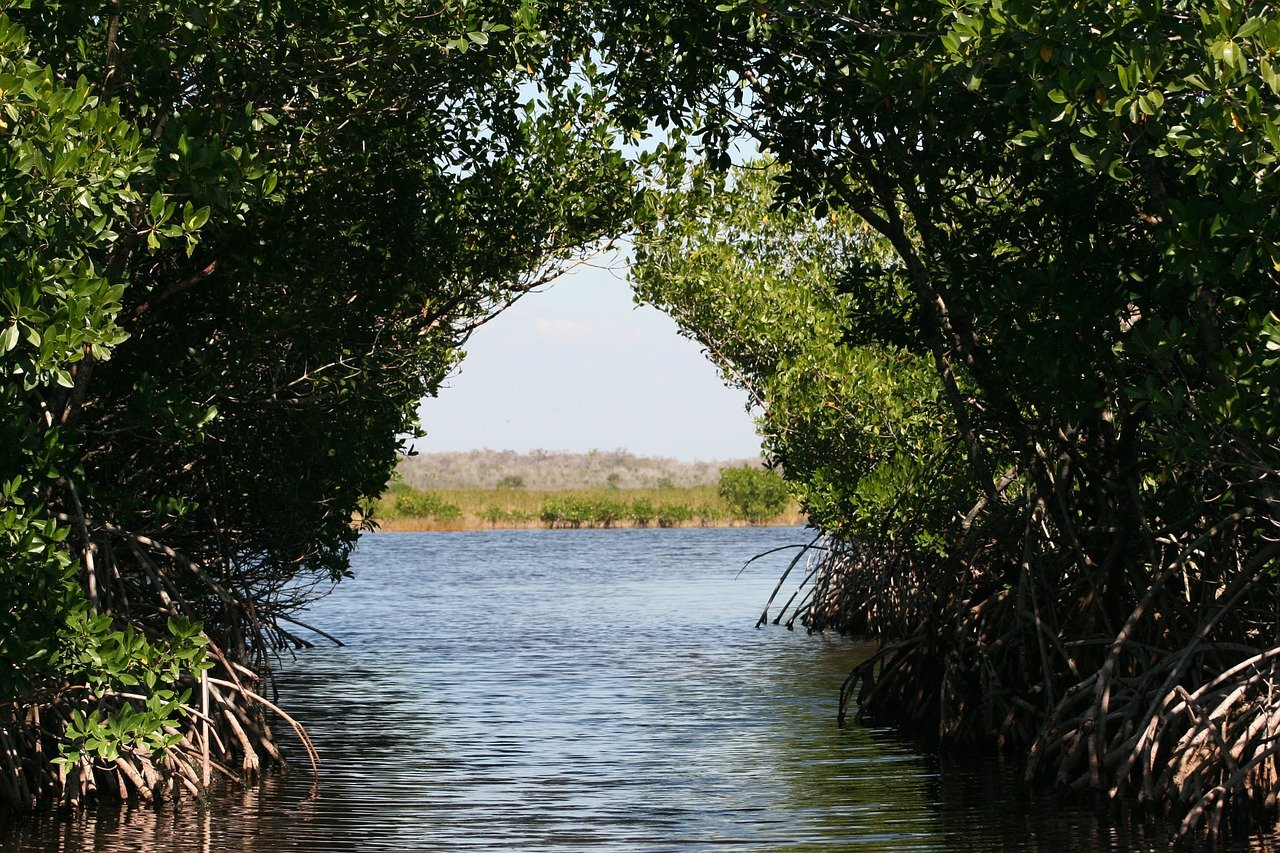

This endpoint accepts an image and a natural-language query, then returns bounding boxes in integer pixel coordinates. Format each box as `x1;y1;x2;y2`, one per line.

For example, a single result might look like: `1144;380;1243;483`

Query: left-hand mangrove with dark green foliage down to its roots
0;0;634;806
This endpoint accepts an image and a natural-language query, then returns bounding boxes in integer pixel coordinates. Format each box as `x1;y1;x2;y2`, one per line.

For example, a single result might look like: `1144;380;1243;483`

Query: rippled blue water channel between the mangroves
0;528;1269;850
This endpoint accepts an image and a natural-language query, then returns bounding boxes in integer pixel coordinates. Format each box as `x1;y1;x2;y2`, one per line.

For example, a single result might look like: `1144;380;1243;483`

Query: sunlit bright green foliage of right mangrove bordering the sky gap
634;161;955;542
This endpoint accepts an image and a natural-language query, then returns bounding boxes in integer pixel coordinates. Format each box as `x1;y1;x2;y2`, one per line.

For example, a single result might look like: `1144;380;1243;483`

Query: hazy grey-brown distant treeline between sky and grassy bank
398;448;760;491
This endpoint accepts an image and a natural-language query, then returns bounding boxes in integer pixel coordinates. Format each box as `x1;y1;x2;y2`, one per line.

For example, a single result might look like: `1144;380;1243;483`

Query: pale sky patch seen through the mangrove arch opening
413;260;760;461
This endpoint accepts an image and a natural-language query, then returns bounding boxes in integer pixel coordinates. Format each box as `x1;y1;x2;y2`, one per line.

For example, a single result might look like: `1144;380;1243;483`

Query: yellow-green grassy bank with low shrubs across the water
363;484;805;532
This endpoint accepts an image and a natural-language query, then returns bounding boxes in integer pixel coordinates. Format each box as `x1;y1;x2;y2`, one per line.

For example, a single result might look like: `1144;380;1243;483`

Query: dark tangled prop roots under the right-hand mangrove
774;502;1280;836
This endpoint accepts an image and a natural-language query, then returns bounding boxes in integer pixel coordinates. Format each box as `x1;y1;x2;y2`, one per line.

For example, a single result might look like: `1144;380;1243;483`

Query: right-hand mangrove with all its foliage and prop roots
600;0;1280;831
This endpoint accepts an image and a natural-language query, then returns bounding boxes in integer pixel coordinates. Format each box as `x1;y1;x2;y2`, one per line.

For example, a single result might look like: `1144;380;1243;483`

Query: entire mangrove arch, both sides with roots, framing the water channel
0;0;1280;829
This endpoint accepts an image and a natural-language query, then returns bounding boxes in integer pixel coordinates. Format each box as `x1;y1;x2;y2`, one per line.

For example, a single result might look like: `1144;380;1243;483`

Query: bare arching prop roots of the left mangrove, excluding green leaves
0;494;340;809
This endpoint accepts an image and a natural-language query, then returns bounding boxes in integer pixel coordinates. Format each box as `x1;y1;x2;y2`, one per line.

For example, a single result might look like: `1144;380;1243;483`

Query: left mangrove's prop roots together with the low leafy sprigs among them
0;499;337;811
